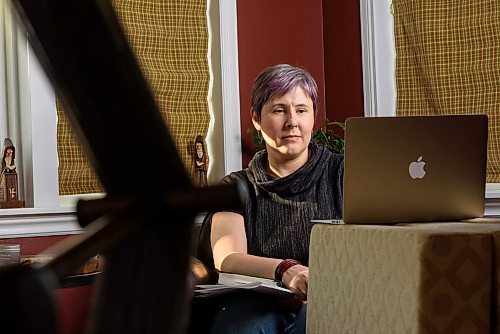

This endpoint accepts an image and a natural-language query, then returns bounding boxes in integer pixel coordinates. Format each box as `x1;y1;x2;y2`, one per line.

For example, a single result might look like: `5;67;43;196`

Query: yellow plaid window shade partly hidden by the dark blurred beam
57;0;210;195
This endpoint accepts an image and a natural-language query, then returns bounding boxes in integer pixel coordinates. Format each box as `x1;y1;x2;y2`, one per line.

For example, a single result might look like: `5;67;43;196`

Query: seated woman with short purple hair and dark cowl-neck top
205;64;343;333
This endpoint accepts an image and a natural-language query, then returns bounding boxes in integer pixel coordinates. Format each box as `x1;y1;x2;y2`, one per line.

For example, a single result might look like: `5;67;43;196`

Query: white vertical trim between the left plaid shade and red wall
207;0;241;184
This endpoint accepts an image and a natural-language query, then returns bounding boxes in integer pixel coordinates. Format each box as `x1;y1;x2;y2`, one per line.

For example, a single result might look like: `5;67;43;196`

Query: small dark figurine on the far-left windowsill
0;138;24;208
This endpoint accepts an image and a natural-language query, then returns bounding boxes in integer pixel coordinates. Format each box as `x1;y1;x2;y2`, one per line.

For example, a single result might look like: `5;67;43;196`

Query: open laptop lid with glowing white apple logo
343;115;488;224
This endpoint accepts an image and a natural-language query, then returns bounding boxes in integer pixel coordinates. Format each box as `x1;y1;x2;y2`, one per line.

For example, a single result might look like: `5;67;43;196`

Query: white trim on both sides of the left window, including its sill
0;0;241;238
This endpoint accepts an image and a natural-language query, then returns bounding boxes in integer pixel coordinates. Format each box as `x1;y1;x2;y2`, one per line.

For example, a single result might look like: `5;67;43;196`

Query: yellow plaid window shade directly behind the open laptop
392;0;500;183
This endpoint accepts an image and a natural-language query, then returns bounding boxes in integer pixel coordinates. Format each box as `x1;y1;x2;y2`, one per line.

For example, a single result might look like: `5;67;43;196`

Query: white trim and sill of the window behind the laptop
361;0;500;215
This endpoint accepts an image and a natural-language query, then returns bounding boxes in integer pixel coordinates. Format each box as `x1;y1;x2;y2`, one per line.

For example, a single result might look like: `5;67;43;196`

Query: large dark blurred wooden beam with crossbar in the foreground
4;0;242;334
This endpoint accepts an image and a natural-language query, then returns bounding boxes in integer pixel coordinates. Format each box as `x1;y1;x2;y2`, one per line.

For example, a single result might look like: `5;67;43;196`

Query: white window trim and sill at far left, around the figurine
0;1;79;237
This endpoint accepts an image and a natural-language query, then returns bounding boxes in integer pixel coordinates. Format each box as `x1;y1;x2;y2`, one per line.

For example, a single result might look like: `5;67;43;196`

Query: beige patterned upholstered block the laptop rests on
307;222;500;333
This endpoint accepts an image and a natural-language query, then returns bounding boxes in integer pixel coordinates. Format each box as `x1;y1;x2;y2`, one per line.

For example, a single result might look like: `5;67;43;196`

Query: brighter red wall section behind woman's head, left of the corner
237;0;326;166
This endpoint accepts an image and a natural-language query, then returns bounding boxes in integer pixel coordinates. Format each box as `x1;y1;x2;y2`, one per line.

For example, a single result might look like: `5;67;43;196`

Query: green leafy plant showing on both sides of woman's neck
247;119;345;154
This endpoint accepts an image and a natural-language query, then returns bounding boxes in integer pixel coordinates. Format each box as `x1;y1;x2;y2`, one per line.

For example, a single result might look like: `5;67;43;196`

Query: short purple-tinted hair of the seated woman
252;64;318;119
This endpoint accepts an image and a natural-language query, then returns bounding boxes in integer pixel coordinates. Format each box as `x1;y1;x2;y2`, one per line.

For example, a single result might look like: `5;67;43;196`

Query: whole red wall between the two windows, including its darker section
237;0;363;166
